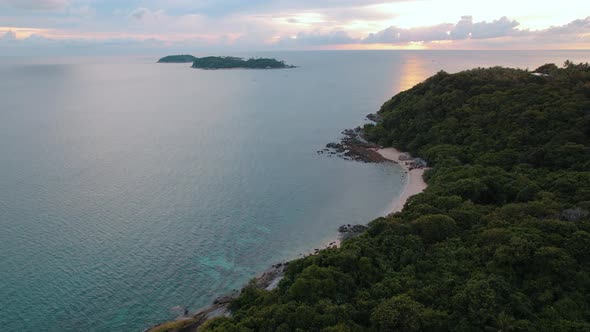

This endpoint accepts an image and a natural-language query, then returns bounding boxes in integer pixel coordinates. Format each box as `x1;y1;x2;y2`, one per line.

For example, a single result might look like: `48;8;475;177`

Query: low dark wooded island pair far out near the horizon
158;54;295;69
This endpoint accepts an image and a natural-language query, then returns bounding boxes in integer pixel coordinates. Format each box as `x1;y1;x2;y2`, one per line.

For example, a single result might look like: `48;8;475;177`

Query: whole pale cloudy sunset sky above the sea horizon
0;0;590;55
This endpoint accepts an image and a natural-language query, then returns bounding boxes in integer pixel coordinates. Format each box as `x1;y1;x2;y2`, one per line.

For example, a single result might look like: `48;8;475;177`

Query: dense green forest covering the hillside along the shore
199;61;590;332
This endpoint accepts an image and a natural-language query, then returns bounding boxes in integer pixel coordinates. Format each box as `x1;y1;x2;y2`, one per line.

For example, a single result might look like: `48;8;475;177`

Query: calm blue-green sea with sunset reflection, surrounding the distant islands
0;52;590;331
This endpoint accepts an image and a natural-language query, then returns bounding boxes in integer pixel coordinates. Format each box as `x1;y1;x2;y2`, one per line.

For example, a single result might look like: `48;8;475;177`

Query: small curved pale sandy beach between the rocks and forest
377;148;426;213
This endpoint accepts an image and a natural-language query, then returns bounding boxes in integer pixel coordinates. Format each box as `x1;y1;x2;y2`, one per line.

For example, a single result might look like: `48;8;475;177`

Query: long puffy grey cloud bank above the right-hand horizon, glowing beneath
266;16;590;49
